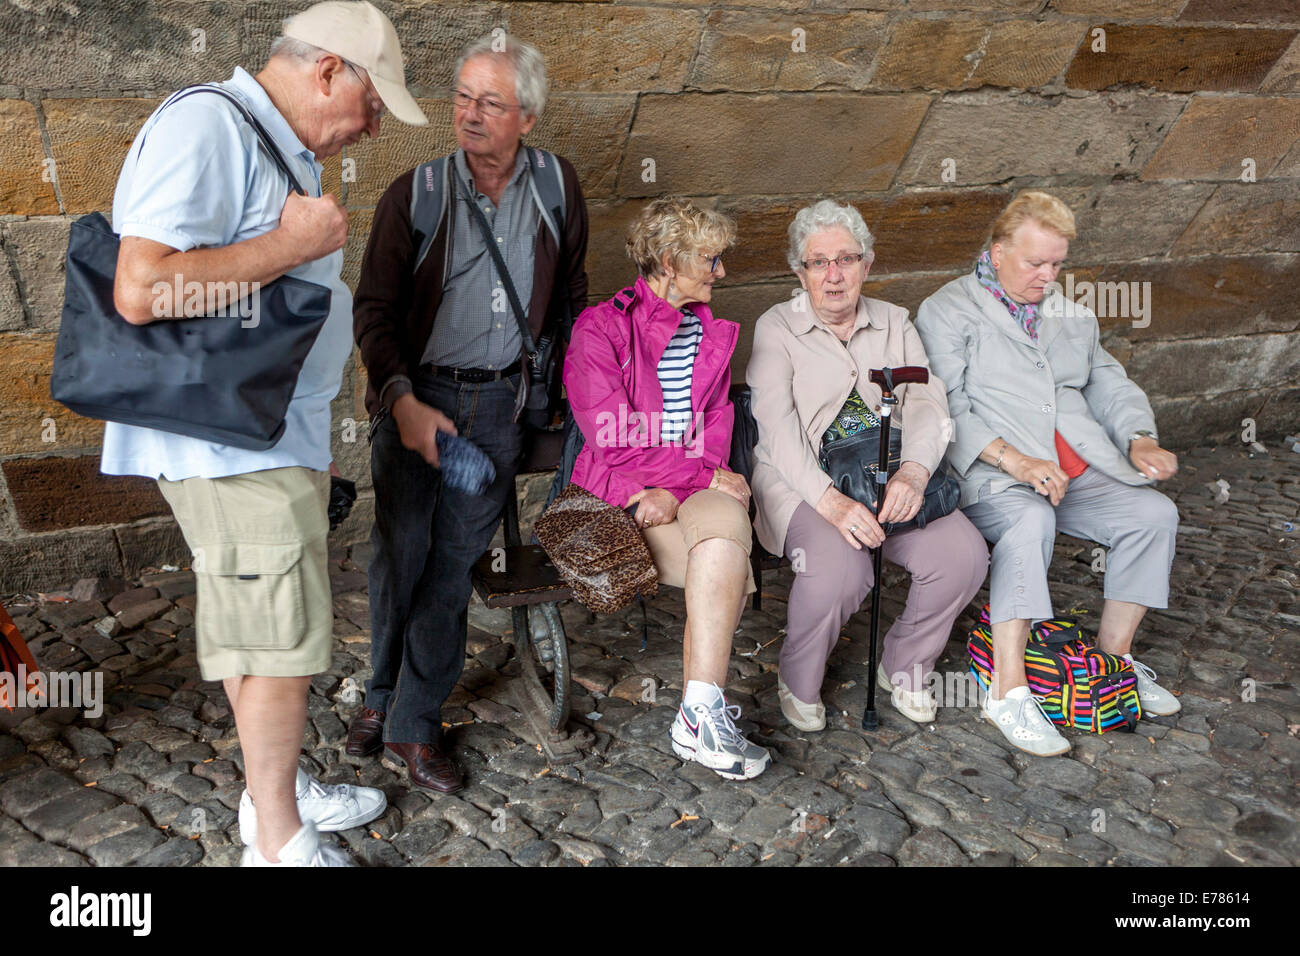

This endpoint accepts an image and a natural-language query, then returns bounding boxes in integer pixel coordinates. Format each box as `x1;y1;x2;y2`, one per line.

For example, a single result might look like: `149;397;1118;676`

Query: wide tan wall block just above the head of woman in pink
619;94;930;196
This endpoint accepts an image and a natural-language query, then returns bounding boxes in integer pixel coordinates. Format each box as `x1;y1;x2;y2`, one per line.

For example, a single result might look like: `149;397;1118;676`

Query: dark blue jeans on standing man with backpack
365;372;523;744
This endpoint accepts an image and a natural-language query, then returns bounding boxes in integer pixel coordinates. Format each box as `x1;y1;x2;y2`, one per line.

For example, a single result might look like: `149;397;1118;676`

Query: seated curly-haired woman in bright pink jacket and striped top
564;199;771;779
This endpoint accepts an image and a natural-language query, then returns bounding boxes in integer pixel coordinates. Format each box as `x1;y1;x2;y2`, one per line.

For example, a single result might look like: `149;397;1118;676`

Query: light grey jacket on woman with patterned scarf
917;272;1156;507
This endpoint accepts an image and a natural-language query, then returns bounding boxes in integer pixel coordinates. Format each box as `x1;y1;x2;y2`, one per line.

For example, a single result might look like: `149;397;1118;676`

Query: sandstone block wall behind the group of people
0;0;1300;593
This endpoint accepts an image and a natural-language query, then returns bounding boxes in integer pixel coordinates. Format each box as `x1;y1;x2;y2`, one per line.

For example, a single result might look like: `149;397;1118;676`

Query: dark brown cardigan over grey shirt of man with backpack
352;148;588;418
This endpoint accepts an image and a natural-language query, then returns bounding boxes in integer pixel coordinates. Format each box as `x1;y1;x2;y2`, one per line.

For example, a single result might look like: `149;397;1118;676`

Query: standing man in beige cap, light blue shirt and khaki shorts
101;3;428;866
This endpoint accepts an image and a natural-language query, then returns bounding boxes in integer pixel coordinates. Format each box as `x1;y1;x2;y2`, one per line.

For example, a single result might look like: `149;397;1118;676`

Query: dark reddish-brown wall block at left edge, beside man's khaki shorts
3;455;169;532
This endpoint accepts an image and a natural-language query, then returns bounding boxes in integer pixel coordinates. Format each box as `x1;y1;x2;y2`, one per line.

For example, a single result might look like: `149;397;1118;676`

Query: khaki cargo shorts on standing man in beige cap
159;468;334;680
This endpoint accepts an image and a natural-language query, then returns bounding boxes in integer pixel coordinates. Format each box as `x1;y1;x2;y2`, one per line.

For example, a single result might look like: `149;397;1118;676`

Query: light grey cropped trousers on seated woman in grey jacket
963;468;1178;624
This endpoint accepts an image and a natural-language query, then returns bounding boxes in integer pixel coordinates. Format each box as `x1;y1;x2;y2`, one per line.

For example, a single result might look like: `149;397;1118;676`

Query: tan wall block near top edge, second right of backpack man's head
686;10;885;92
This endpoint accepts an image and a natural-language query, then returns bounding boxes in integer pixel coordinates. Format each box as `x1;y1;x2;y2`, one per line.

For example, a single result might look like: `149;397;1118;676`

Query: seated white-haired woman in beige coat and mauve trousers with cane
746;199;988;731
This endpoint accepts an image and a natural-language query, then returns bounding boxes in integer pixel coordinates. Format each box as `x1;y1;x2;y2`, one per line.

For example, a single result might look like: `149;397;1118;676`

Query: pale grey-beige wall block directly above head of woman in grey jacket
897;92;1182;187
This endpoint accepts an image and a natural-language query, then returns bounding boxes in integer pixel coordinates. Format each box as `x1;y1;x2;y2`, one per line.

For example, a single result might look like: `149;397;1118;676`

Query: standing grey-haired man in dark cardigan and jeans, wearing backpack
347;35;588;792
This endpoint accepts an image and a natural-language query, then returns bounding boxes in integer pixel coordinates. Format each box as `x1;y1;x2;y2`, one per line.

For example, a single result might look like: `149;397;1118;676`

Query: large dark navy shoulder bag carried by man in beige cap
49;86;330;451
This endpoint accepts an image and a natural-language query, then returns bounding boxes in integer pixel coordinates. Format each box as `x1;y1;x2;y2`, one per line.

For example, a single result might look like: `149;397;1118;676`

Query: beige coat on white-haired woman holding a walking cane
745;291;950;554
